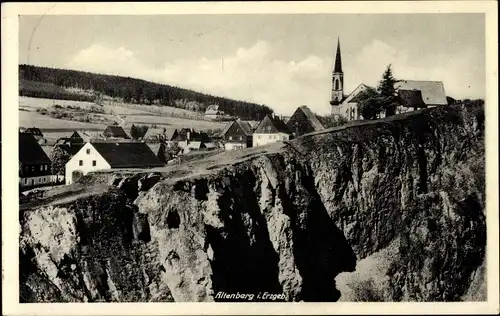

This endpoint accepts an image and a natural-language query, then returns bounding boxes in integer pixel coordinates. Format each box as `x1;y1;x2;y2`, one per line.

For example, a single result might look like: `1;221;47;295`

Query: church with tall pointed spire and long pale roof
330;39;448;121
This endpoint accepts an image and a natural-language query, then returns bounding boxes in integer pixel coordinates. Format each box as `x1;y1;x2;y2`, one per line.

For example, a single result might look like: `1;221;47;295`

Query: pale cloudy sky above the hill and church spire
19;13;485;115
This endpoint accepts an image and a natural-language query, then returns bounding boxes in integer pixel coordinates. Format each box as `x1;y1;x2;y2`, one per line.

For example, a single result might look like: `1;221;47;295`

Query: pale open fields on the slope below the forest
19;97;225;143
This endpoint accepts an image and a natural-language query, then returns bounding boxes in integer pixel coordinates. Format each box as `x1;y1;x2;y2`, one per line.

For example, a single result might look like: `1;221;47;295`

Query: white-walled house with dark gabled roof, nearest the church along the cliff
253;114;291;147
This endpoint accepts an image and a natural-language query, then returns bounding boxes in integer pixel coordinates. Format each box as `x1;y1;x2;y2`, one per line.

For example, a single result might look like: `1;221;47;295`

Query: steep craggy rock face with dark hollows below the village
20;103;486;302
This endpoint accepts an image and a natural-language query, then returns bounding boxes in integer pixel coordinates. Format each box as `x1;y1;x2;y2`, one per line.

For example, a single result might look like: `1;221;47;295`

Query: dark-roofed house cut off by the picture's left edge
19;133;53;187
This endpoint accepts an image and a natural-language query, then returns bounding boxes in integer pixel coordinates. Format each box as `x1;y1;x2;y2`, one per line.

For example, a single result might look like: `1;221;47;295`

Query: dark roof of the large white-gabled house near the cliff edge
91;142;163;168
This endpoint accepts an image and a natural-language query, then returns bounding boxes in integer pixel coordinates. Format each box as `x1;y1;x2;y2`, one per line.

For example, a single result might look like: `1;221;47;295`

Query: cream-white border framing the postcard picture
1;1;499;315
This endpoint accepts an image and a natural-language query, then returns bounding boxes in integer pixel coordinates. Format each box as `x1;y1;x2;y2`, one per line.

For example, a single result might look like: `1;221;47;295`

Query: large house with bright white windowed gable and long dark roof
65;142;164;184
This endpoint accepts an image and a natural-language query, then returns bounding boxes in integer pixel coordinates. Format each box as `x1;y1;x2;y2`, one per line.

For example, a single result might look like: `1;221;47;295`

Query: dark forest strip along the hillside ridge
19;65;273;120
